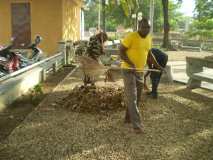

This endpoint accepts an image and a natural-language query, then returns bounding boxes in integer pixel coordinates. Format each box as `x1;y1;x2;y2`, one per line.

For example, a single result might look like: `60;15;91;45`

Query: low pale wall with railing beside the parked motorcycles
0;42;74;110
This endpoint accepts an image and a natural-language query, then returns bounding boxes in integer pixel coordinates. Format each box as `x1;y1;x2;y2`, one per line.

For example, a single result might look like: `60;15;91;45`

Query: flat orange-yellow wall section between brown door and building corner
31;0;62;55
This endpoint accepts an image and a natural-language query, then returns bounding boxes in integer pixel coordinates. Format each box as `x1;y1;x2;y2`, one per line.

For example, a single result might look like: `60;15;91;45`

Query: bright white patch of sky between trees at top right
180;0;195;17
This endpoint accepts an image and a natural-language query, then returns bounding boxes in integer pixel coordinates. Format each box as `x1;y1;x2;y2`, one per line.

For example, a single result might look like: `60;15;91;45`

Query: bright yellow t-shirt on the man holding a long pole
121;32;152;70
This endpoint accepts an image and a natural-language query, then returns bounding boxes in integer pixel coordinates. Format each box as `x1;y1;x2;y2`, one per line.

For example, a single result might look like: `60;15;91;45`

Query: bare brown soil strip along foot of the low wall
0;68;72;142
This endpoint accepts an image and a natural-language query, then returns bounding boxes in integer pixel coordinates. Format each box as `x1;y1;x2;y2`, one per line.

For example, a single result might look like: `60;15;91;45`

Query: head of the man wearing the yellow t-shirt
138;18;150;38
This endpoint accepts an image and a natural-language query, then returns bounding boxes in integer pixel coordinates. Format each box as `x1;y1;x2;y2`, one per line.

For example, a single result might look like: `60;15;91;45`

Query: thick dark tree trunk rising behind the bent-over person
162;0;170;49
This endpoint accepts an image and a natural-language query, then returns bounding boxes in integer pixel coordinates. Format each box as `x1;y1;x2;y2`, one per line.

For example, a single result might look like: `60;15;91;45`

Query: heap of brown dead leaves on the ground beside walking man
62;86;125;113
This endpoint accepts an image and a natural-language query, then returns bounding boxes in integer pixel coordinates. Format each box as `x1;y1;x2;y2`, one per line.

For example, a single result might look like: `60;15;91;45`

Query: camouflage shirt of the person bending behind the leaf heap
86;36;104;60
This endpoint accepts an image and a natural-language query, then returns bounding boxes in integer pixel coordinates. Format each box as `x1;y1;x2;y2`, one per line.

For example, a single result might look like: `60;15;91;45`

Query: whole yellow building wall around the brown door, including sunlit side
0;0;81;55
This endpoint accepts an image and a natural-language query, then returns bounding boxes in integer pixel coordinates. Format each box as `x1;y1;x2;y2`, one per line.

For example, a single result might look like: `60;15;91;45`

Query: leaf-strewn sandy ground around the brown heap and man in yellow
0;57;213;160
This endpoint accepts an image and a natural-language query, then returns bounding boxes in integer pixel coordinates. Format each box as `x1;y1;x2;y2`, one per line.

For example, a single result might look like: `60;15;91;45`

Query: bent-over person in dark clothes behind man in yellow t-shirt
144;48;168;99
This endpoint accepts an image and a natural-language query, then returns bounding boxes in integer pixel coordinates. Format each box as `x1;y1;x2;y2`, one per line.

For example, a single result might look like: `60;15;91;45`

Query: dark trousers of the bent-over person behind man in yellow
150;72;162;97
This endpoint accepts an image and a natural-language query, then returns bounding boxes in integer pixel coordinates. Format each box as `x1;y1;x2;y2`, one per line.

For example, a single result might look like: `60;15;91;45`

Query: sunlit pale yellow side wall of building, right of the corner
62;0;81;41
